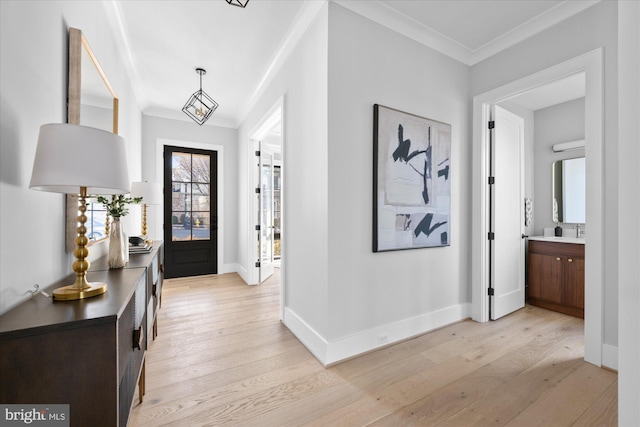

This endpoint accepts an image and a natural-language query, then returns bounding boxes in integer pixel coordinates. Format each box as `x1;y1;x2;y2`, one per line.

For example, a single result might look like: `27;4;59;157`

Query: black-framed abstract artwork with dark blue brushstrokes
373;104;451;252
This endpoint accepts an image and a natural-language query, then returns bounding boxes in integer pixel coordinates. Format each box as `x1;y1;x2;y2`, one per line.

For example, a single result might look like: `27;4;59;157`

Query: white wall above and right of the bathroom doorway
471;1;618;346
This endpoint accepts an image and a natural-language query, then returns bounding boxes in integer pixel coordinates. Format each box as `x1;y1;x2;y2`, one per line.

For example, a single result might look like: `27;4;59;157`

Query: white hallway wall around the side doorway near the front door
238;5;329;348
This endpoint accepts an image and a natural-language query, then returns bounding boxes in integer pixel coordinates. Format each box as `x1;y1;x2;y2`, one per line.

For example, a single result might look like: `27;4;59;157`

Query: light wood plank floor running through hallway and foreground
129;274;617;427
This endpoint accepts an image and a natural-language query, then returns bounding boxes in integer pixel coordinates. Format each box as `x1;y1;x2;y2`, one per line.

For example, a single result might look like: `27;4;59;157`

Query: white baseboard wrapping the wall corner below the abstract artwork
284;303;471;366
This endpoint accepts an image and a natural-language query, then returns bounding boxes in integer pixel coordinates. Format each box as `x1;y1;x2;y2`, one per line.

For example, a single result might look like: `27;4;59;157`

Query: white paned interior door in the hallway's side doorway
257;143;274;283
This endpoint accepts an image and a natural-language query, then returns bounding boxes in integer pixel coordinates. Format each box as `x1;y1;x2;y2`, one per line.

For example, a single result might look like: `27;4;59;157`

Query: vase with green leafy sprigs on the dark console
98;194;142;268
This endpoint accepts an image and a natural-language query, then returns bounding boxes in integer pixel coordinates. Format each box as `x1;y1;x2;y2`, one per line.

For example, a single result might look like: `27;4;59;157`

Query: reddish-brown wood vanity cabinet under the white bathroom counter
527;240;584;318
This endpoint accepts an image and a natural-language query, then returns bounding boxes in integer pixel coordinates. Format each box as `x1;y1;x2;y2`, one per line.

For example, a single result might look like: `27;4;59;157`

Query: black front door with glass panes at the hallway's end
164;146;218;278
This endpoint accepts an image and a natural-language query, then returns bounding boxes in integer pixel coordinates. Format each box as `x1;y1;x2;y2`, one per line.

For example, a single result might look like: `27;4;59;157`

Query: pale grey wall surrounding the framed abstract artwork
326;3;471;363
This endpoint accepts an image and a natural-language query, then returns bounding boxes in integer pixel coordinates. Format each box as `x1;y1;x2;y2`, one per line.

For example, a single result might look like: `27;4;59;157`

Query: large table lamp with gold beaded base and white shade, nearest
29;124;129;300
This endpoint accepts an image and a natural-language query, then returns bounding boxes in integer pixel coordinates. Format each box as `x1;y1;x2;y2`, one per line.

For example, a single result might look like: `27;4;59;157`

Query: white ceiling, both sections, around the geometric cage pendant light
102;0;598;127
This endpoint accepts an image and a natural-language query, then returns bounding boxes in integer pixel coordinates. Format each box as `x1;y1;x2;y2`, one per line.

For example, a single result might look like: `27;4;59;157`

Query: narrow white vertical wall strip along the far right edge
614;2;640;426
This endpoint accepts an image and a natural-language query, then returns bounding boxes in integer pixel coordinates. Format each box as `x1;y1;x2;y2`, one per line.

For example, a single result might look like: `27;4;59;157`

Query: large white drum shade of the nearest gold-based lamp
29;123;130;194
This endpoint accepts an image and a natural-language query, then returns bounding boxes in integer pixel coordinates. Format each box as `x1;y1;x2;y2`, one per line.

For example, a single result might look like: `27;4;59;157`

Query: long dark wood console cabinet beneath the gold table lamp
0;242;162;426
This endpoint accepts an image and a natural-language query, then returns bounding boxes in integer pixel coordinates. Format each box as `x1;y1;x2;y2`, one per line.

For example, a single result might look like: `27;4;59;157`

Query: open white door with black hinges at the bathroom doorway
490;106;525;320
